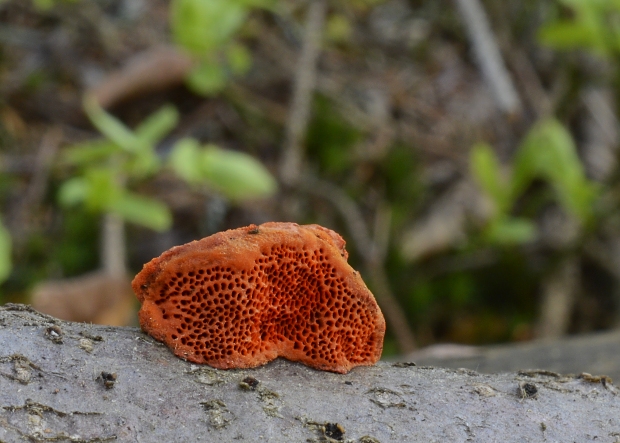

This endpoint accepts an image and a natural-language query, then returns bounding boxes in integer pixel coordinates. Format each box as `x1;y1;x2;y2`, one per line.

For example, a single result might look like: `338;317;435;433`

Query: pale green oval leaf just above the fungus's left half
201;145;277;200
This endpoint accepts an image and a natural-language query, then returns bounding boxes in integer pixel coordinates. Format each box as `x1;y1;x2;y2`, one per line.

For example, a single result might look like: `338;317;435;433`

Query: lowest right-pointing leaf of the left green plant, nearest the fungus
109;192;172;232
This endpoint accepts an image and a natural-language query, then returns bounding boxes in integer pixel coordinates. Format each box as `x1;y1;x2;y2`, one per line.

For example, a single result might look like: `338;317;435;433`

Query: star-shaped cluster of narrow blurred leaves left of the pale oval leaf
58;97;178;231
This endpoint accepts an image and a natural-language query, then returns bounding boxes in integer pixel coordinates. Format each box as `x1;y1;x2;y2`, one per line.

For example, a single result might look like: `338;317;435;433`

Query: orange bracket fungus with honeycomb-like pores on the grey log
133;222;385;373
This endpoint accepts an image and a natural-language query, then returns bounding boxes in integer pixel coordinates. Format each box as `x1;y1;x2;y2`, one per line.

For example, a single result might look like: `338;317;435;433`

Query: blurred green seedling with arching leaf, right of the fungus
470;119;599;245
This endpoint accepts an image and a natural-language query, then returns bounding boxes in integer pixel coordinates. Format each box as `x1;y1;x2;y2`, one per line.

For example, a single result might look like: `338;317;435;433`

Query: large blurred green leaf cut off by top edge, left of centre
170;0;248;55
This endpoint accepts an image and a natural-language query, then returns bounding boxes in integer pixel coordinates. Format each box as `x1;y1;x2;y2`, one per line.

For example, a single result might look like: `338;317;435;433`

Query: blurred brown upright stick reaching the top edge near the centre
280;0;327;185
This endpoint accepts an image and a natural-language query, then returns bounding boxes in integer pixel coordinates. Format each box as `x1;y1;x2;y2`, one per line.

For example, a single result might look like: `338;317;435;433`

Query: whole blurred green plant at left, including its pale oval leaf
58;97;277;231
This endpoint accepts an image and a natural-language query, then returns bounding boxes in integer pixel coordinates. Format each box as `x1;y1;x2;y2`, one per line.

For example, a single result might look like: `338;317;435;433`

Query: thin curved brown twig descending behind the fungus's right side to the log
298;175;416;354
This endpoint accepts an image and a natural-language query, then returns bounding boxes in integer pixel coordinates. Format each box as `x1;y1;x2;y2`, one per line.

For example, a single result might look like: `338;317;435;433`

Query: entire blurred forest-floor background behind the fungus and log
0;0;620;355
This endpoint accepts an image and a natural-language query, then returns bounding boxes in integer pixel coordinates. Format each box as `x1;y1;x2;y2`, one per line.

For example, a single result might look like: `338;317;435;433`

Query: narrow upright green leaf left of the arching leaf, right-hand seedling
470;143;512;212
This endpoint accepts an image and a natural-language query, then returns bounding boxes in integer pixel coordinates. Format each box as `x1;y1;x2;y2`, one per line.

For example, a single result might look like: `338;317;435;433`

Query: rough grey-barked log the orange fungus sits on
0;305;620;443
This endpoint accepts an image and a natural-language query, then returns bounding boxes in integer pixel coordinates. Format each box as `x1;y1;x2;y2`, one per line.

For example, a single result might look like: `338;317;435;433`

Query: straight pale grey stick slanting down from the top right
455;0;523;115
